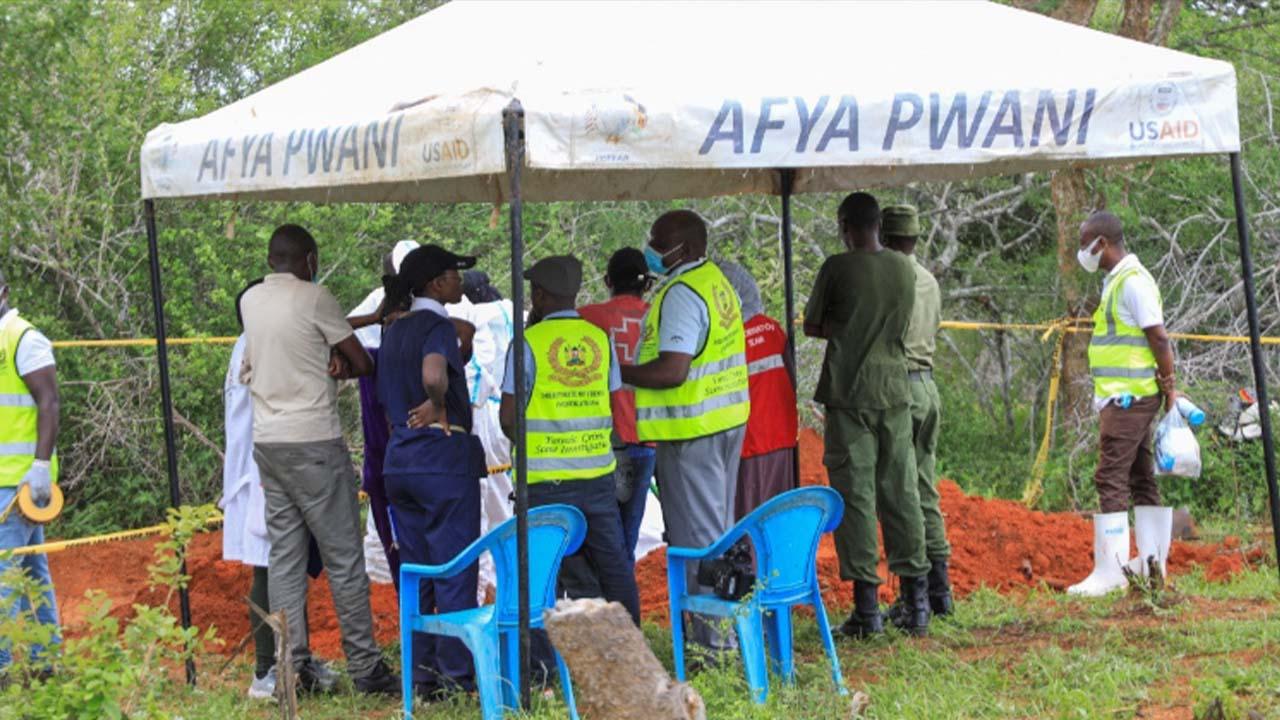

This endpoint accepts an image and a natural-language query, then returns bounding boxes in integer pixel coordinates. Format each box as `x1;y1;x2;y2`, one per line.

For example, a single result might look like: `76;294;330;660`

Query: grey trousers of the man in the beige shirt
253;438;381;678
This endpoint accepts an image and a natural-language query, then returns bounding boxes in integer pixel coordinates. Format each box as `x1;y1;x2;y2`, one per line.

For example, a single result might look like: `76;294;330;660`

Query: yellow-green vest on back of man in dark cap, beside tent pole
525;318;617;483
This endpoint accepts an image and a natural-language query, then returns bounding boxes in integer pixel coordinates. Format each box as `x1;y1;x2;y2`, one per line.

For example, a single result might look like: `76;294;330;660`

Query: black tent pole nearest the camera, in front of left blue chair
502;100;530;707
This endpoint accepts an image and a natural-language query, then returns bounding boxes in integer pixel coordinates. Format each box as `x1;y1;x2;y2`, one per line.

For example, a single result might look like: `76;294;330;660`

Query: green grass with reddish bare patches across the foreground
147;568;1280;720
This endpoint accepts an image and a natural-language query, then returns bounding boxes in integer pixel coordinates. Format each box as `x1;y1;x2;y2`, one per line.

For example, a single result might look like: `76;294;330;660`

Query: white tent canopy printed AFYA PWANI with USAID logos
142;0;1239;202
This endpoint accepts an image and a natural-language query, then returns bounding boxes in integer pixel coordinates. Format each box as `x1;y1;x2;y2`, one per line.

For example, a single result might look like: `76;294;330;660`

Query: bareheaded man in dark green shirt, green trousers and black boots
804;192;929;637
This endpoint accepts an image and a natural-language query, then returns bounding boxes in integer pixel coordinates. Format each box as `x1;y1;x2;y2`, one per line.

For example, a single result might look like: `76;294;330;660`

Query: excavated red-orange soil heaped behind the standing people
50;430;1263;650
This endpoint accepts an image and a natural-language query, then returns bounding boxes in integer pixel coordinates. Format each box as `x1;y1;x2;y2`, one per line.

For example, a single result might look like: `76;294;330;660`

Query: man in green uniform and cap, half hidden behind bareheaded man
881;205;952;623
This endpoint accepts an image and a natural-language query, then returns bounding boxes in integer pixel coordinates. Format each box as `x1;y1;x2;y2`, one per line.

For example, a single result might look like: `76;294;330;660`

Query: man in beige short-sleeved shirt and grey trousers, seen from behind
239;224;399;694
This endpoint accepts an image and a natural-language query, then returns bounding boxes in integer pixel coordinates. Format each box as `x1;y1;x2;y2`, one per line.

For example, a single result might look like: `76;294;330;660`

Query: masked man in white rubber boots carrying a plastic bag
1068;211;1178;596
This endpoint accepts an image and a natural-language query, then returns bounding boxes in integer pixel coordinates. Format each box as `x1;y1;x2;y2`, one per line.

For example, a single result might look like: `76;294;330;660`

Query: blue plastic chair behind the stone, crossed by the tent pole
401;505;586;720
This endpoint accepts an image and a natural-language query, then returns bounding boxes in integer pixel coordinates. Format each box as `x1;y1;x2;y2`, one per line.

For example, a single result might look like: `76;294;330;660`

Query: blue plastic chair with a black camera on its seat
667;487;849;703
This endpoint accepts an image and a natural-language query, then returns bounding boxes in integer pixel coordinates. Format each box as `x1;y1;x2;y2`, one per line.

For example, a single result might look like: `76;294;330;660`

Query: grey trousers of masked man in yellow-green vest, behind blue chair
654;425;746;651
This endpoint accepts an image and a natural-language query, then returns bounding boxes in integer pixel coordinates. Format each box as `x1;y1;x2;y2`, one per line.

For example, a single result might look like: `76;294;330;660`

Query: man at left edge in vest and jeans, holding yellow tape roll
0;269;60;683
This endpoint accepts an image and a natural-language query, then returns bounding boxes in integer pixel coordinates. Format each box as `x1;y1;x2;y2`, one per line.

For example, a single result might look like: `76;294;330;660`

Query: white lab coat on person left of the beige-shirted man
218;336;271;568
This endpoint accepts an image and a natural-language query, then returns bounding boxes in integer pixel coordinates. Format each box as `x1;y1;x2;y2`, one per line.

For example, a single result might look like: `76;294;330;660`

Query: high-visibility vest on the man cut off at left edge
0;313;58;488
